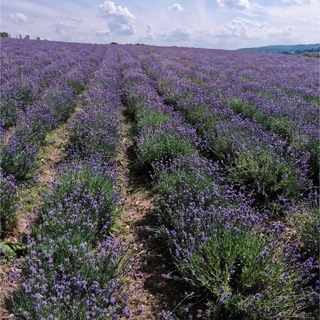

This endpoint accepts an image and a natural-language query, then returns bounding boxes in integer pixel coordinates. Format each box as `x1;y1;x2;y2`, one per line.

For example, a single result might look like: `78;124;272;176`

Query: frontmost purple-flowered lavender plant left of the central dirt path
15;239;129;320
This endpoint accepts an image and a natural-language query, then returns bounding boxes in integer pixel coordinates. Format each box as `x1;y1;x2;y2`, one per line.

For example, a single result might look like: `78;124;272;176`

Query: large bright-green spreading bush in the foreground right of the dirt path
183;226;299;319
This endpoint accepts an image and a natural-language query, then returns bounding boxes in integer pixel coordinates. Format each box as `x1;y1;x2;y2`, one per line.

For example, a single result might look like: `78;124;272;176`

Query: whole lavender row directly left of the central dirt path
14;46;130;319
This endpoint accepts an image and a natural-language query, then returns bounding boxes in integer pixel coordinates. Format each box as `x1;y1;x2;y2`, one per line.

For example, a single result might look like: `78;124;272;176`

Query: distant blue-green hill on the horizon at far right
238;43;320;54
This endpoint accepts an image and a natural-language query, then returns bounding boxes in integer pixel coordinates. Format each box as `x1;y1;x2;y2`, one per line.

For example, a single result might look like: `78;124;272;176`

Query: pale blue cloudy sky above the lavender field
0;0;320;49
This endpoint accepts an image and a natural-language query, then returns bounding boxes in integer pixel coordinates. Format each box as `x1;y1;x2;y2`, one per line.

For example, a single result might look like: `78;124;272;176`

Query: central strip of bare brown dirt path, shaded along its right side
117;123;180;320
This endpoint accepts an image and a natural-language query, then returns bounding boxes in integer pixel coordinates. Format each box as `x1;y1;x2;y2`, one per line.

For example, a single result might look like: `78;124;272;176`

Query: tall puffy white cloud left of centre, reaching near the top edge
99;1;136;35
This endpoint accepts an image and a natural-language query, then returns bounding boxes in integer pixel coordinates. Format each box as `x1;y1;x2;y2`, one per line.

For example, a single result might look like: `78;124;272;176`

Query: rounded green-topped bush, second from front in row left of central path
37;165;117;245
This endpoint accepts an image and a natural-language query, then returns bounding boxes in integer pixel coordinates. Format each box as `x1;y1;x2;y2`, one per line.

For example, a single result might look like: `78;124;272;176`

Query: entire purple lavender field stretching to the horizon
0;39;320;320
